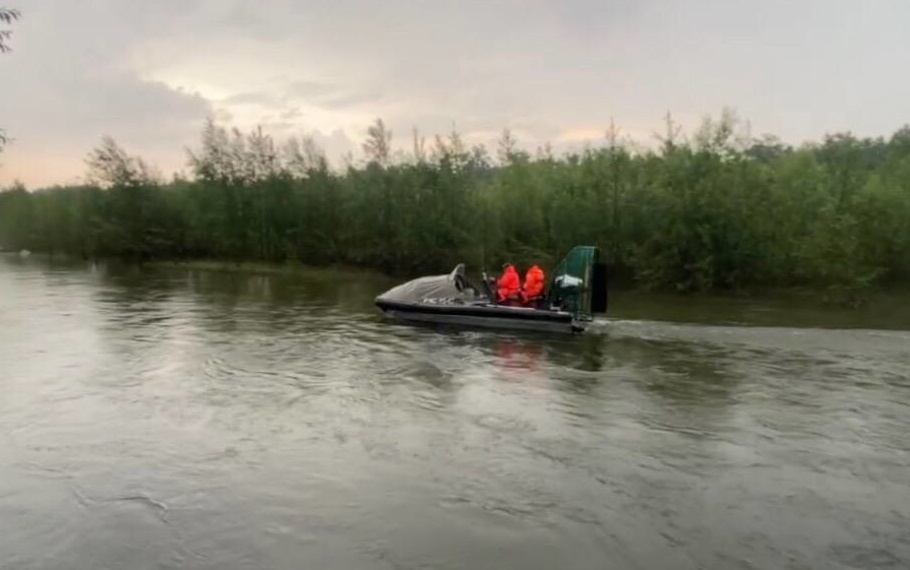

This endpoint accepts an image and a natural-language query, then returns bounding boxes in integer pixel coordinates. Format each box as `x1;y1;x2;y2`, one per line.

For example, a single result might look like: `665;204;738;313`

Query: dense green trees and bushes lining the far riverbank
0;112;910;298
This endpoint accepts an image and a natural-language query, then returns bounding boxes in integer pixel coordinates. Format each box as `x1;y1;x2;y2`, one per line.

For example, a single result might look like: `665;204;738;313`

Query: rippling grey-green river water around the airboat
0;256;910;570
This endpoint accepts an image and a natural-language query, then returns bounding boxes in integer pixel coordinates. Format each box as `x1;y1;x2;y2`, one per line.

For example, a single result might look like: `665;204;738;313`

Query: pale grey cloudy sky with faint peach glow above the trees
0;0;910;188
